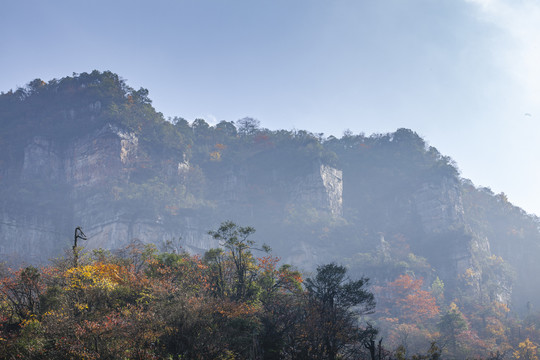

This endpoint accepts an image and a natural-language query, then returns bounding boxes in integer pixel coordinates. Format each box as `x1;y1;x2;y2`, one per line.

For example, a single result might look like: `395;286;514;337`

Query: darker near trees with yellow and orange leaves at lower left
0;222;377;359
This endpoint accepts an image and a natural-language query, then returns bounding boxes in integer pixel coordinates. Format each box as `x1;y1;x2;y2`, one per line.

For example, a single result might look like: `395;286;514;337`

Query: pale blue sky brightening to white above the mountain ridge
0;0;540;215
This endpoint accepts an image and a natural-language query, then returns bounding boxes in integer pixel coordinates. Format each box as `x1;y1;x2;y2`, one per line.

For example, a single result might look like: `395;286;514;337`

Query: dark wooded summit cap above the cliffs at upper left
0;70;186;155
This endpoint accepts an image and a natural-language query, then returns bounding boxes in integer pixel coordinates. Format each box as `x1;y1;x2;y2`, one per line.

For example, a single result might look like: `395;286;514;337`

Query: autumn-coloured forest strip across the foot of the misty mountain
0;221;540;360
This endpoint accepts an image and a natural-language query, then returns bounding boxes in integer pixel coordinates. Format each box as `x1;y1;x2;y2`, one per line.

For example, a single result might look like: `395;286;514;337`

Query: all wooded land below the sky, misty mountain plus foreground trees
0;71;540;360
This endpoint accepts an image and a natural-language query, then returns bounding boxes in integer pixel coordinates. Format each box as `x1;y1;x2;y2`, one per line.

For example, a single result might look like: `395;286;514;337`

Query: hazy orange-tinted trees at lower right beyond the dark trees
373;272;540;359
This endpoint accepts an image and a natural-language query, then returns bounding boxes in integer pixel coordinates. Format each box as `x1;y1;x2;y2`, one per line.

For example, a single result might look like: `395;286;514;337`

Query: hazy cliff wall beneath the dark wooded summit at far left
0;124;141;262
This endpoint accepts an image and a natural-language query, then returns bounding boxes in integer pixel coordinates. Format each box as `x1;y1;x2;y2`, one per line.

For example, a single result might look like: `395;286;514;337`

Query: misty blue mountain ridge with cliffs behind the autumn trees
0;71;540;320
